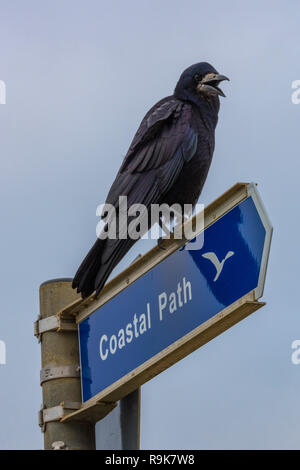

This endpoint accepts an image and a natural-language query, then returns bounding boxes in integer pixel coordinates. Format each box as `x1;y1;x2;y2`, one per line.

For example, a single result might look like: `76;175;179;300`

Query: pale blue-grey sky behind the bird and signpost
0;0;300;449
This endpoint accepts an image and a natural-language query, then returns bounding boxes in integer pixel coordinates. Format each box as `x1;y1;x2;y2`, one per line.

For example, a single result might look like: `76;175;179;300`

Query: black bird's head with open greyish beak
174;62;229;100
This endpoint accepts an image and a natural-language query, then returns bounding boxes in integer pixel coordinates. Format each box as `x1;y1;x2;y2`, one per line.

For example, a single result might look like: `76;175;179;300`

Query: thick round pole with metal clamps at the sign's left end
35;279;95;450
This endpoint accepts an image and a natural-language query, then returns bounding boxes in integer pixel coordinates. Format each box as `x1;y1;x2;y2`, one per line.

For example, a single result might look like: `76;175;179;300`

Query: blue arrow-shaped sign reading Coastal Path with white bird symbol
79;186;272;402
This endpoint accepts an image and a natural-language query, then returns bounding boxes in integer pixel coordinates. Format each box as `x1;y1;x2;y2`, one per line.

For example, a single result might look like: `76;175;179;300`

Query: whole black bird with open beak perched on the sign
72;62;229;298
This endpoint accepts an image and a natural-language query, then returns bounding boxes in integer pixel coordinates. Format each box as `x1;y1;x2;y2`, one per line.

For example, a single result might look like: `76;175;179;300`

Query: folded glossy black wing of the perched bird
106;97;197;211
